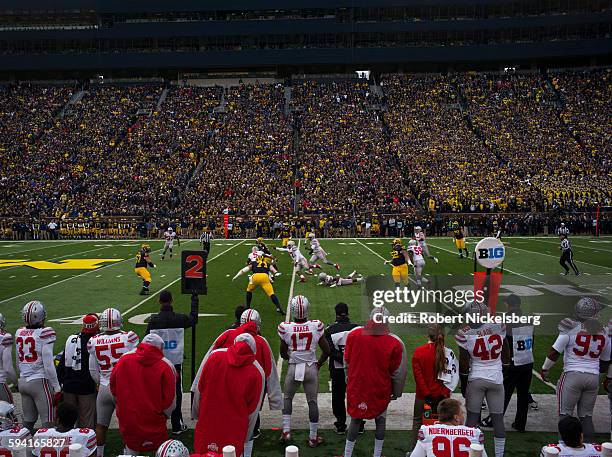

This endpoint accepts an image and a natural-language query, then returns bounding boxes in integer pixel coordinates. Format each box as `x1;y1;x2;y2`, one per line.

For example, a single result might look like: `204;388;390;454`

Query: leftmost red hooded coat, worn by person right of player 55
110;343;176;452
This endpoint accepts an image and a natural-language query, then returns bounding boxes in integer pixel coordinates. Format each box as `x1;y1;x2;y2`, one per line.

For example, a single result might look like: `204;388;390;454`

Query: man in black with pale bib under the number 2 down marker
146;290;198;435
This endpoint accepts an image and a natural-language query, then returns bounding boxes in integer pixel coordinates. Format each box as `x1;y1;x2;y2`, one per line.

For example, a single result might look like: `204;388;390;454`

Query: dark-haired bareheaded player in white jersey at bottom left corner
33;403;96;457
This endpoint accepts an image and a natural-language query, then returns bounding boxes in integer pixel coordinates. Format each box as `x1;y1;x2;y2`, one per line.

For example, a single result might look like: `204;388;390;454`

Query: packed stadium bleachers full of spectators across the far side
0;69;612;223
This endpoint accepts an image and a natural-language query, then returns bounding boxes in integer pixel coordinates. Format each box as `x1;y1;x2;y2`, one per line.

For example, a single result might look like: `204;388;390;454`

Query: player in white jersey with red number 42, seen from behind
455;301;510;457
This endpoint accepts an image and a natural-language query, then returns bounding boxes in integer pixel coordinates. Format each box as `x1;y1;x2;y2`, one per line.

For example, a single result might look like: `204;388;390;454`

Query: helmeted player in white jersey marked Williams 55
87;308;139;457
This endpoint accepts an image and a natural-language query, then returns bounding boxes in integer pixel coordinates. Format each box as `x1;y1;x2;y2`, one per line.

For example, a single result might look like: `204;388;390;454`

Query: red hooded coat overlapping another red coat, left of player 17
193;341;264;455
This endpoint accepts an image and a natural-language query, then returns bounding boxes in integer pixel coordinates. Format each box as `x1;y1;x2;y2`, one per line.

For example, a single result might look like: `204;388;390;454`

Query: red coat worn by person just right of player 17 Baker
344;320;407;419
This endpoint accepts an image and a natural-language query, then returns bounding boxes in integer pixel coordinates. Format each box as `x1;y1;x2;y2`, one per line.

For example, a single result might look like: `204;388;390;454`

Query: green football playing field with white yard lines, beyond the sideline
0;237;612;455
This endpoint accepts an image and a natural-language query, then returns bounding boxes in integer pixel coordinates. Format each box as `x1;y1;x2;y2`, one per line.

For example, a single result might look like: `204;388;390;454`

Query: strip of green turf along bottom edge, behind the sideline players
101;430;607;457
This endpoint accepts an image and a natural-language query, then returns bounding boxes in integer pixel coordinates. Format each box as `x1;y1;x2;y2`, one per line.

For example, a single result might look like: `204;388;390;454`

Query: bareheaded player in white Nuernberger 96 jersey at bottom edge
407;398;487;457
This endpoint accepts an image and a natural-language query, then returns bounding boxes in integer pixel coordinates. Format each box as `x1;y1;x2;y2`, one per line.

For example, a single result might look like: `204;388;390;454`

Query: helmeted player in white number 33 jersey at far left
15;300;61;431
